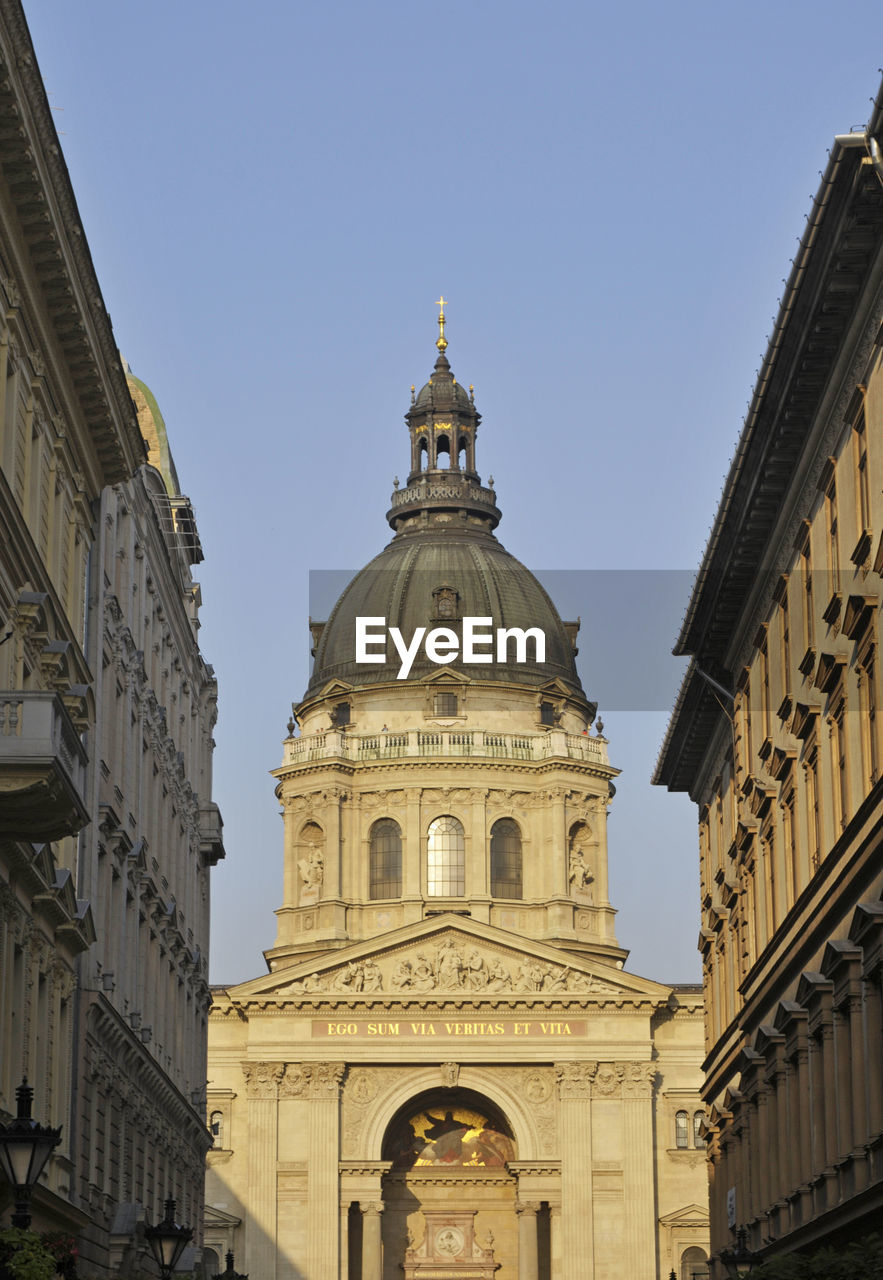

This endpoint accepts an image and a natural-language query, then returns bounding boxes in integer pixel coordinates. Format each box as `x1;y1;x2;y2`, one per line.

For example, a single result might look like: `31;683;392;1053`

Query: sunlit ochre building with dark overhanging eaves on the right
656;87;883;1254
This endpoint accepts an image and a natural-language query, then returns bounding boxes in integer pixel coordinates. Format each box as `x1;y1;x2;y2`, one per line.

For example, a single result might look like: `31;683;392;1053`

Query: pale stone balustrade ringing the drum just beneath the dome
284;728;609;764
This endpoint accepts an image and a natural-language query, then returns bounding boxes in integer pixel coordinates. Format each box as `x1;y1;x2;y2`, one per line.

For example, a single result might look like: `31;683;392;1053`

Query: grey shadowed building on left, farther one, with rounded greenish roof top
68;372;224;1271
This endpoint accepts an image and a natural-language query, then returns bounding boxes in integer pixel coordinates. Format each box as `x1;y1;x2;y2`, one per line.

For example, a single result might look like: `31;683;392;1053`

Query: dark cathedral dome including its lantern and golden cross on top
307;312;594;721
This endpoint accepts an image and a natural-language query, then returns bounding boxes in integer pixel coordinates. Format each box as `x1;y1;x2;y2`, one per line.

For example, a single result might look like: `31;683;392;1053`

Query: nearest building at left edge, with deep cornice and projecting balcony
0;0;145;1231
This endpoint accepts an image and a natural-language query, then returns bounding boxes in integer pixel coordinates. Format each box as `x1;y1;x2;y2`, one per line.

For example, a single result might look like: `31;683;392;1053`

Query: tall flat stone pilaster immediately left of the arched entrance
307;1062;346;1280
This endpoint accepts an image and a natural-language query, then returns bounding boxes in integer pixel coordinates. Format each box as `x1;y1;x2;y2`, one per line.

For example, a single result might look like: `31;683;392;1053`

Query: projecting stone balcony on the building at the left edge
0;690;88;842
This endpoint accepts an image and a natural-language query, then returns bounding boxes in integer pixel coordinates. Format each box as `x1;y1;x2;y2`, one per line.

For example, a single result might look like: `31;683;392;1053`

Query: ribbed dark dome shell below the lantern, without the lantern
307;527;585;699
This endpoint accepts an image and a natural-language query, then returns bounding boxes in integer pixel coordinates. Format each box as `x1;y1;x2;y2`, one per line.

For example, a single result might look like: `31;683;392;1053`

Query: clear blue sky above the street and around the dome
26;0;880;982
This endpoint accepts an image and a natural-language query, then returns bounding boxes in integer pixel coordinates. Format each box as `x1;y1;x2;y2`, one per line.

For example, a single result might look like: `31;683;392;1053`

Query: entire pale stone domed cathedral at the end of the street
205;323;708;1280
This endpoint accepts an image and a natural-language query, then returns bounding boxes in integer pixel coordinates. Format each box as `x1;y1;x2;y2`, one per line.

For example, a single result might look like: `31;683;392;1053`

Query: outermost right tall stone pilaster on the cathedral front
621;1062;656;1276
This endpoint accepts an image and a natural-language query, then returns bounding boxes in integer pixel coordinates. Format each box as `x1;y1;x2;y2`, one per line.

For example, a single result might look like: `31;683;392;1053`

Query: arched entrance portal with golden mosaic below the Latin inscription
349;1089;549;1280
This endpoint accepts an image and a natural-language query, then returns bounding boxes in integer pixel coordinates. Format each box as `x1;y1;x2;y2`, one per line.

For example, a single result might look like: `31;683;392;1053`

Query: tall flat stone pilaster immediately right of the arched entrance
555;1062;598;1280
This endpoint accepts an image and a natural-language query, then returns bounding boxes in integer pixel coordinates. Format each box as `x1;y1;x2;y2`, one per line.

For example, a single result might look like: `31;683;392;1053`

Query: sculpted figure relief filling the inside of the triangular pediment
276;934;618;996
